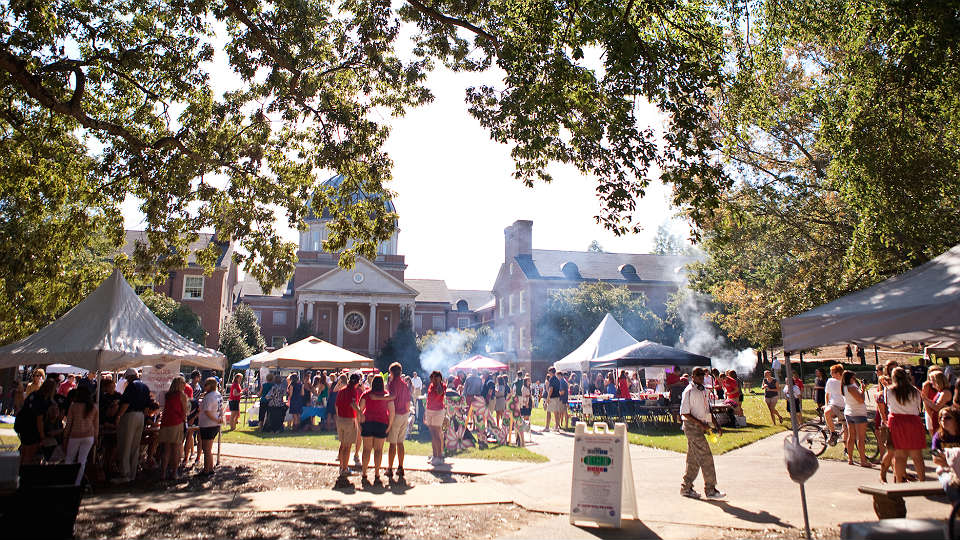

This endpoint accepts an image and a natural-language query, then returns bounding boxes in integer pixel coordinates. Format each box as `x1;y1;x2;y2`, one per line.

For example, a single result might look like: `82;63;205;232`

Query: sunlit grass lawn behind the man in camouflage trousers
530;390;816;455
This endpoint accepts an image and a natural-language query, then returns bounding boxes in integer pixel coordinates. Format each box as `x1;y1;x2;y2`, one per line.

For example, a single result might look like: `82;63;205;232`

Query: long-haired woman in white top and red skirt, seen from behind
884;367;927;482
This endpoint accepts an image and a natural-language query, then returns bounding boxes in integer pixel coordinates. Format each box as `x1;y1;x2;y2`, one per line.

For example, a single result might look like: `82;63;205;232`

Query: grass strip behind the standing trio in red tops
223;420;547;463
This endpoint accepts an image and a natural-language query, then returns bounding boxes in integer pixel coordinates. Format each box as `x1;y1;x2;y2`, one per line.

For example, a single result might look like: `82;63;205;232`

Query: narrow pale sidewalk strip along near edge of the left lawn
220;443;530;476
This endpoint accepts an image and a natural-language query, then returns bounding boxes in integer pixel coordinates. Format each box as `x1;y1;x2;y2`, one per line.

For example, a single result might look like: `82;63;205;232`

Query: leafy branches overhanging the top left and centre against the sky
0;0;723;300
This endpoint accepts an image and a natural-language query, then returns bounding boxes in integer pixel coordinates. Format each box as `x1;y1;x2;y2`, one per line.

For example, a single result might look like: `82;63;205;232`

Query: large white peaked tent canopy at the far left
0;270;226;371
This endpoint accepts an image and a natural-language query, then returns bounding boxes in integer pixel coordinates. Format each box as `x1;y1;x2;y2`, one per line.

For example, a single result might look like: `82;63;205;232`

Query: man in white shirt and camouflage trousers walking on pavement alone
680;367;726;500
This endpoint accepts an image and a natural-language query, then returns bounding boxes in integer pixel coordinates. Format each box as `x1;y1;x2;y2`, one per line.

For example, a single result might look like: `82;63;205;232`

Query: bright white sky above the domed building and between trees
124;23;685;289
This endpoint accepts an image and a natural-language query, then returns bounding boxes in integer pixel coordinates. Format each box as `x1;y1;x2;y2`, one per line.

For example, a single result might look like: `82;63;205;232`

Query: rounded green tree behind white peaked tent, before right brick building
533;283;663;360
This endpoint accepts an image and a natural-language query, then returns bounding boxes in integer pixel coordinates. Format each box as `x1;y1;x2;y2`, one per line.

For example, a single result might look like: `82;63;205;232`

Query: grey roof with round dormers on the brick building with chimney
516;249;695;283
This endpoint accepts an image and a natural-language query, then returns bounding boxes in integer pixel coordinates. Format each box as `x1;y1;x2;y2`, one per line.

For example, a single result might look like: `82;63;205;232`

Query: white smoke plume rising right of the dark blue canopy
677;276;757;374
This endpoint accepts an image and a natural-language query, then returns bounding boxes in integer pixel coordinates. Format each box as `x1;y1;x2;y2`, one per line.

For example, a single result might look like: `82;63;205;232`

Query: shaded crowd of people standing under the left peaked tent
12;368;224;484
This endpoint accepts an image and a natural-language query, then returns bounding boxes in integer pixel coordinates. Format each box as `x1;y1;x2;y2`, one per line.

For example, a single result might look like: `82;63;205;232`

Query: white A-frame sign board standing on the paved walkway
570;422;637;527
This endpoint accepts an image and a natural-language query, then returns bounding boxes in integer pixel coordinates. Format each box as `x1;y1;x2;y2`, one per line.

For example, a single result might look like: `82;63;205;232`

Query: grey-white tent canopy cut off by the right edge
780;245;960;352
